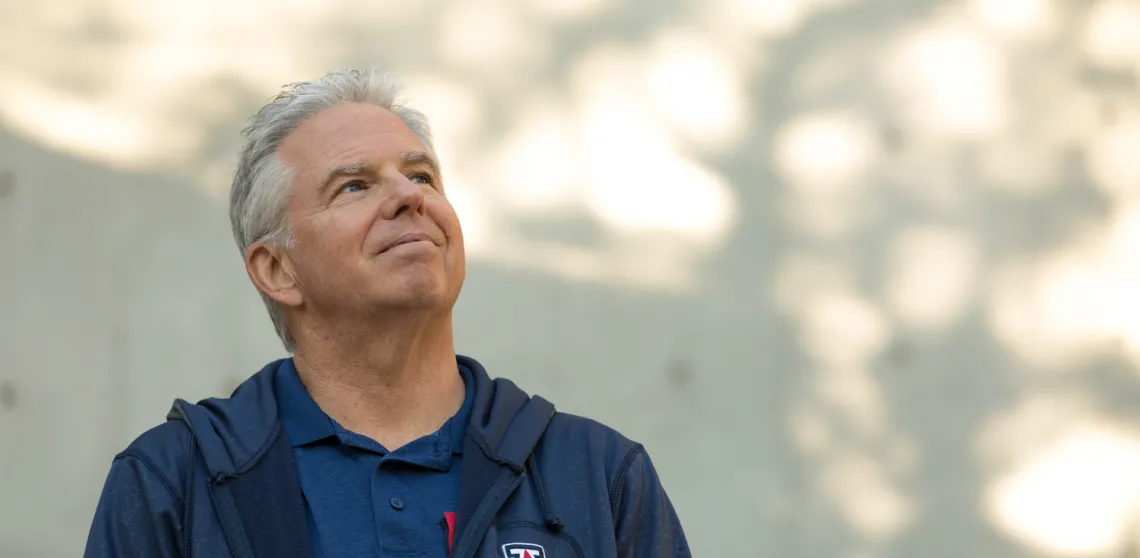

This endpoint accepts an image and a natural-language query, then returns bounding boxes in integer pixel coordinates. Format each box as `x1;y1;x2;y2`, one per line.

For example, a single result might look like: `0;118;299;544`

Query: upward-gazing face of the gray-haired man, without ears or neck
266;104;465;324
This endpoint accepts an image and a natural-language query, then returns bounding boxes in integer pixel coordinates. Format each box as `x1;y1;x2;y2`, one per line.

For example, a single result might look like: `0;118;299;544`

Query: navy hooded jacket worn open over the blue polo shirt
84;356;691;558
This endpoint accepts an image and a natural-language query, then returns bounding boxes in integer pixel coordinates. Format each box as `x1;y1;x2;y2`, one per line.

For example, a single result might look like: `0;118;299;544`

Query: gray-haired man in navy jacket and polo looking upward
86;71;690;558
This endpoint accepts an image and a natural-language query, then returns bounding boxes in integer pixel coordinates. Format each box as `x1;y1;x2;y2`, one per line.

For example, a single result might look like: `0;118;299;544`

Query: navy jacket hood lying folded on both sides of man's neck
166;356;554;478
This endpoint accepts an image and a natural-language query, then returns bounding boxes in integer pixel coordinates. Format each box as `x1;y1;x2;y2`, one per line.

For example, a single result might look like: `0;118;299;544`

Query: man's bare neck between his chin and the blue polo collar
293;313;464;451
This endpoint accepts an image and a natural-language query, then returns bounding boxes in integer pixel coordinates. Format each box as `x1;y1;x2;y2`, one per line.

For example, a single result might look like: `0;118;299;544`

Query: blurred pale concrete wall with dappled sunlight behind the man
0;0;1140;558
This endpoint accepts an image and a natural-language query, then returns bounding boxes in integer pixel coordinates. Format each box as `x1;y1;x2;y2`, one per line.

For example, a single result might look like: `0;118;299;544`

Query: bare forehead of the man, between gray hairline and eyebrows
277;103;424;176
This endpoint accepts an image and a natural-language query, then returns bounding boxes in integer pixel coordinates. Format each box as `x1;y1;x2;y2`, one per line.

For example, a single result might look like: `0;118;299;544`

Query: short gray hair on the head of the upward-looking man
229;68;434;353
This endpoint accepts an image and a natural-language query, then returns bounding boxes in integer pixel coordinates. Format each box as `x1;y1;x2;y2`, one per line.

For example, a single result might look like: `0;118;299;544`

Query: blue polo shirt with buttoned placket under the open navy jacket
275;358;474;558
